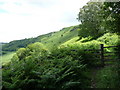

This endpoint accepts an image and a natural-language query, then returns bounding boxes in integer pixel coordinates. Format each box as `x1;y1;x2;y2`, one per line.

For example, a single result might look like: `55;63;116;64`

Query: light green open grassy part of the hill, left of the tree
41;26;78;49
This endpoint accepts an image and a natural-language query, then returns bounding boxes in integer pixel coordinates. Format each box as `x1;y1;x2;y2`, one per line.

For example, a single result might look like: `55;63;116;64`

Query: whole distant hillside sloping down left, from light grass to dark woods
2;25;78;52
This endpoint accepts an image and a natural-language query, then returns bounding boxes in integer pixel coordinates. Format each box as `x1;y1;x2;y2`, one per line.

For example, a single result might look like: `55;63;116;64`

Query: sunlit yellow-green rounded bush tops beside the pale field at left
11;42;48;60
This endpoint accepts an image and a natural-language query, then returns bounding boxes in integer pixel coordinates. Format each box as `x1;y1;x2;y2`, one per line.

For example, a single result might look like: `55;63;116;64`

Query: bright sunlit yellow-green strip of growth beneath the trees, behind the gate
61;33;118;46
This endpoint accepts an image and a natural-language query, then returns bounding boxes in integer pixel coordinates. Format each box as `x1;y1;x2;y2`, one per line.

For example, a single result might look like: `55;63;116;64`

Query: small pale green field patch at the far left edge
0;52;15;65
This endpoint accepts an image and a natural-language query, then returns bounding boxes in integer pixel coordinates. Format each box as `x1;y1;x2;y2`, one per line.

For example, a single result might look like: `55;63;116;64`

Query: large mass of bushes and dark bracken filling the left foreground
3;43;88;90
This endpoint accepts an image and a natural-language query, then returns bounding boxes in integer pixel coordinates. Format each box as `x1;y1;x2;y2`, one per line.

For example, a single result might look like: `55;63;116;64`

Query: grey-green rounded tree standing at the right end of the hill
78;2;103;37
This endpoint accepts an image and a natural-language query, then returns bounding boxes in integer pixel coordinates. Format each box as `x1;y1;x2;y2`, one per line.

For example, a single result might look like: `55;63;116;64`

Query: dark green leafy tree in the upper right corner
104;1;120;34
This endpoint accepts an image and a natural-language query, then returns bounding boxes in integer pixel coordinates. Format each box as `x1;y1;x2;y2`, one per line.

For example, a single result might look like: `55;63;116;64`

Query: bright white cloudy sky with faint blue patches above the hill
0;0;89;42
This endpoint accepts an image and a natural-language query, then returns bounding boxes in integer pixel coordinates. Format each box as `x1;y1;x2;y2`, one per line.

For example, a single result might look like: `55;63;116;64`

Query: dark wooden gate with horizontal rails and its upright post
84;44;119;66
